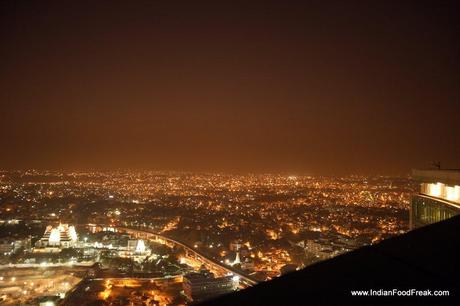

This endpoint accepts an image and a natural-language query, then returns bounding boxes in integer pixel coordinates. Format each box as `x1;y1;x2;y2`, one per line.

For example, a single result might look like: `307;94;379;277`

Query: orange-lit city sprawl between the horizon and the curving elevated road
0;171;415;280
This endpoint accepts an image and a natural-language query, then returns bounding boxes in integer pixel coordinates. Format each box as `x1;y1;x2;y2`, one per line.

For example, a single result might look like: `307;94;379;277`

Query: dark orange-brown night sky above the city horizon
0;1;460;175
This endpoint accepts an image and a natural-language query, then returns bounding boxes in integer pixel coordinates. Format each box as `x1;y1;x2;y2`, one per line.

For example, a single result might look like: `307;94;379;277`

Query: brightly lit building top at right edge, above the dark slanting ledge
410;170;460;229
